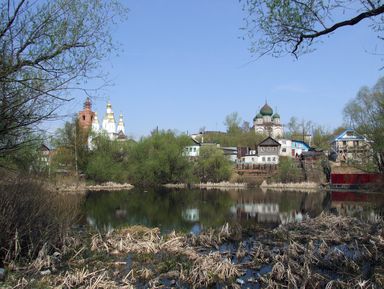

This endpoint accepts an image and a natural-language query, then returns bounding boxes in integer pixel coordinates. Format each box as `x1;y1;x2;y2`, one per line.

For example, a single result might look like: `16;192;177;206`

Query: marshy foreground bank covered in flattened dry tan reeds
0;214;384;289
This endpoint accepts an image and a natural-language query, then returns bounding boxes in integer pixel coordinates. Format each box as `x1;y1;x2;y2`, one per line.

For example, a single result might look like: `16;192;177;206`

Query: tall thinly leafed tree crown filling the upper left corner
0;0;125;157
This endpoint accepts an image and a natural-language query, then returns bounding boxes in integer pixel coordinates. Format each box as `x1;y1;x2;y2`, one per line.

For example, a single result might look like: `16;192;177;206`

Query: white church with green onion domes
253;103;283;139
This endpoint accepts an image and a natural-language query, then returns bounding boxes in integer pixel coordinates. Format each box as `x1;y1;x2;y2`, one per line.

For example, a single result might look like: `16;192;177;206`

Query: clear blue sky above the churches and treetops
55;0;384;139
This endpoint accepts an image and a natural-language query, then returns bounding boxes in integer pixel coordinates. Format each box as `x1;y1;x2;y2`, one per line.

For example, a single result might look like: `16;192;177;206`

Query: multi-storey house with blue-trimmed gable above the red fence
331;129;372;163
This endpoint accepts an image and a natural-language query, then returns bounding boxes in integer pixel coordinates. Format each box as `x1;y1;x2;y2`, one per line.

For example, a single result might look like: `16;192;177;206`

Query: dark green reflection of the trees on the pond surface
85;188;231;231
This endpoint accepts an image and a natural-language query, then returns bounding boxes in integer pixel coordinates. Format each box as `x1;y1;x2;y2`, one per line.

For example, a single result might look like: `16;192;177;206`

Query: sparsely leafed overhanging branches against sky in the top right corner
243;0;384;57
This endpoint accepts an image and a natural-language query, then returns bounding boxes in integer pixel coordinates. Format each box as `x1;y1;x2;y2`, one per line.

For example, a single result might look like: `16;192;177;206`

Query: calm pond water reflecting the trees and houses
84;188;384;233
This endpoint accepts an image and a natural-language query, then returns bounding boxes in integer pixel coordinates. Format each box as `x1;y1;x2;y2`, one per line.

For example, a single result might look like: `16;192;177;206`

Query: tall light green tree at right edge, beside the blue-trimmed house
344;78;384;173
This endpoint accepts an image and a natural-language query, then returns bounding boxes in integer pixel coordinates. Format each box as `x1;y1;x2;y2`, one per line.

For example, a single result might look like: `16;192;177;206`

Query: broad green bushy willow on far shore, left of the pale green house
128;131;192;186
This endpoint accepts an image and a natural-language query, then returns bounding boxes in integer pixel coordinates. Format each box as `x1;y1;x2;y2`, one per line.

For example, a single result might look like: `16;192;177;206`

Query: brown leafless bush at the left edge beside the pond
0;176;80;263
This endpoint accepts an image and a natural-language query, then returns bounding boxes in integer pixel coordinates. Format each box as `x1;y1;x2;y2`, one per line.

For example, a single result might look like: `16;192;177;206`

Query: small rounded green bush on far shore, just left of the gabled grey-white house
195;145;232;182
